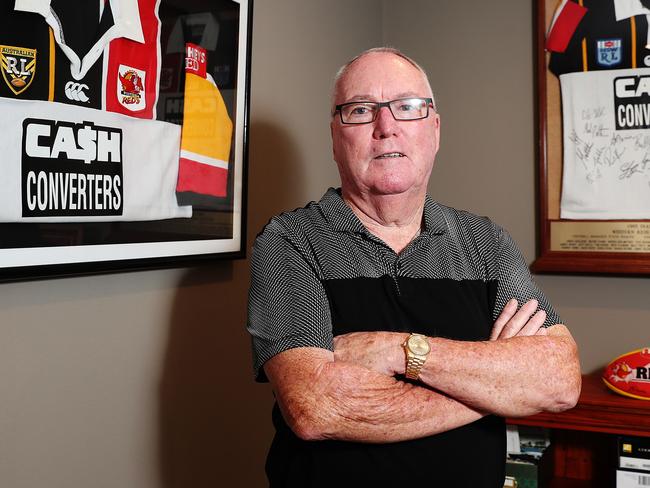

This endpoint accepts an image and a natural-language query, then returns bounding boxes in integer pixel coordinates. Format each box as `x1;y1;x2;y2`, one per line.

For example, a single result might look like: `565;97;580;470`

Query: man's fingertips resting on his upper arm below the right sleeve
490;298;547;341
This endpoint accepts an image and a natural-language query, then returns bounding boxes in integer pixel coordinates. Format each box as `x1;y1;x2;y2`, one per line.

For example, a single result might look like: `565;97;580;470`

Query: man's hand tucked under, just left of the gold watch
334;332;408;376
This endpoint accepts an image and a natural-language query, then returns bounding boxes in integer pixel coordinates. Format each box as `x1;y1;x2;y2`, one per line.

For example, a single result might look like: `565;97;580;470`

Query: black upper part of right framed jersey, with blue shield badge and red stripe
546;0;650;76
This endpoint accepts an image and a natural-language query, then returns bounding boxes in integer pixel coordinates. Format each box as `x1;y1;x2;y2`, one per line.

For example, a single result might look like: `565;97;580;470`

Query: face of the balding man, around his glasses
331;53;440;195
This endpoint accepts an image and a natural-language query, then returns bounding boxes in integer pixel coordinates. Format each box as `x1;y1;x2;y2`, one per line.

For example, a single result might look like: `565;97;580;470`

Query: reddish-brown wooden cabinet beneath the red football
508;374;650;488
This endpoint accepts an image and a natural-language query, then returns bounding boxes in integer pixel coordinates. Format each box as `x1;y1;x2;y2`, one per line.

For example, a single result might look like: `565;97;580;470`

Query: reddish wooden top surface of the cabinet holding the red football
508;374;650;437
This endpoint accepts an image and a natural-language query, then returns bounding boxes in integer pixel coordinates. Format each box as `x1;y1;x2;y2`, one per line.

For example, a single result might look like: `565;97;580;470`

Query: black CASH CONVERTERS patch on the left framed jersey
21;118;124;217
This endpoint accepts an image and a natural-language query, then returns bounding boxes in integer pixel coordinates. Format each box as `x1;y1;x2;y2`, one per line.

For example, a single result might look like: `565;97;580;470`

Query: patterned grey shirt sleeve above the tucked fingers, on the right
492;225;562;327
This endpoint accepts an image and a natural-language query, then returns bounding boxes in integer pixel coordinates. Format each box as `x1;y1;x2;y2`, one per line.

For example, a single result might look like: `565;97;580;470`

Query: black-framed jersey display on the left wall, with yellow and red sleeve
0;0;252;279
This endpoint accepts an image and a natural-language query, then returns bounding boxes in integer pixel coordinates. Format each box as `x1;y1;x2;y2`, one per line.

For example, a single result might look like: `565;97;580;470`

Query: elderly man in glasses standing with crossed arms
248;48;580;488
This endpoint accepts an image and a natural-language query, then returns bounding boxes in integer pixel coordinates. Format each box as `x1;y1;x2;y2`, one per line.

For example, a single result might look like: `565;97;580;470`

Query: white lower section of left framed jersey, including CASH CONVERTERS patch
0;98;192;222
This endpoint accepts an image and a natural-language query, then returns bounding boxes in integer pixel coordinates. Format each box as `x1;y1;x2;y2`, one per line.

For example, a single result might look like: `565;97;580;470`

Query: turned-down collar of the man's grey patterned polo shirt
319;188;447;235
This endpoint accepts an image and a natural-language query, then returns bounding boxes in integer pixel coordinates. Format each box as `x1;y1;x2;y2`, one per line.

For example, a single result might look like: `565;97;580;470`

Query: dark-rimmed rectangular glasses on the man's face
334;98;433;124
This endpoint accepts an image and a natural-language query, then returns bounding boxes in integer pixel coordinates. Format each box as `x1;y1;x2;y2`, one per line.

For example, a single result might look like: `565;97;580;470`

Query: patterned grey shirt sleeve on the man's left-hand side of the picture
247;226;334;382
